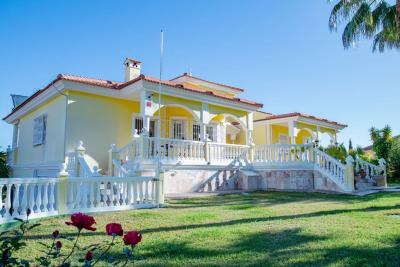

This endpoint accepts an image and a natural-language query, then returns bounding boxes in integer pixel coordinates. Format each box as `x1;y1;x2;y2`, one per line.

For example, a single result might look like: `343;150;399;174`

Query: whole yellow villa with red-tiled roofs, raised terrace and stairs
4;58;382;198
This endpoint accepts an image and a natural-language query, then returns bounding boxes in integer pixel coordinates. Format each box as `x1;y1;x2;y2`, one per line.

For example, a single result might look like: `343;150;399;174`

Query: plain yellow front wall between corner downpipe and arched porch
66;91;140;170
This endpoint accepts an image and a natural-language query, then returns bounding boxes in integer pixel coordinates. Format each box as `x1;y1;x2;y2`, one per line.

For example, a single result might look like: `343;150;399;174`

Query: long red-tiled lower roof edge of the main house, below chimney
3;74;263;120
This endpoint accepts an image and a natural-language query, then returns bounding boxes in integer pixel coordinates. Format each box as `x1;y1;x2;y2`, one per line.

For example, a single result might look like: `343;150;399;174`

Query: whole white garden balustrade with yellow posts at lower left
0;176;163;224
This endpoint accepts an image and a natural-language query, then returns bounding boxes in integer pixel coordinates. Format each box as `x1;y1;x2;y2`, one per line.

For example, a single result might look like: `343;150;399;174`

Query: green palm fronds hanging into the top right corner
329;0;400;52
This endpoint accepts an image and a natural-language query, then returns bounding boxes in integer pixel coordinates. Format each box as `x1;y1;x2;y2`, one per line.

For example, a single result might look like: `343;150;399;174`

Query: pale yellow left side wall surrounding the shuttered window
13;96;66;177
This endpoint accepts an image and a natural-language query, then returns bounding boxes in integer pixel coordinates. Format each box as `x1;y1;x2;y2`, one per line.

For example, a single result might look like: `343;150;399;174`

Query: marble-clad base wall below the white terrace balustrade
142;168;341;194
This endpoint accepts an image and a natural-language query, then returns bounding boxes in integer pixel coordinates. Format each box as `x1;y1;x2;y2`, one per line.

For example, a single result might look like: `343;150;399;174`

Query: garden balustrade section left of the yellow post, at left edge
0;178;58;223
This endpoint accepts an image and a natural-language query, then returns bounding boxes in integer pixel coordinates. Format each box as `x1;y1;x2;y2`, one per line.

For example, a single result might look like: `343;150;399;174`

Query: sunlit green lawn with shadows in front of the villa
10;192;400;266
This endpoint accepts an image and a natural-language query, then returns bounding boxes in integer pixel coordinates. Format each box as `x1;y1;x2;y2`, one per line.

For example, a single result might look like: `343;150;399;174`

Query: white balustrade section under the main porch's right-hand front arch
206;143;249;162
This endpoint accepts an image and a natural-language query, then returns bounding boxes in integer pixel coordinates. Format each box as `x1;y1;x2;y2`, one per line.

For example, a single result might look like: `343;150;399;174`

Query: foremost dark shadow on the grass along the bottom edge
122;228;400;266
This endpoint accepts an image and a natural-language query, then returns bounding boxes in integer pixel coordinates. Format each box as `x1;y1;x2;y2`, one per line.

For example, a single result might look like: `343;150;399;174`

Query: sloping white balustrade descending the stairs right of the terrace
314;149;346;190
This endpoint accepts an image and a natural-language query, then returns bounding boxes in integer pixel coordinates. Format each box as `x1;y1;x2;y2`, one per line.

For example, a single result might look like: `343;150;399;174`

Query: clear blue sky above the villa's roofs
0;0;400;148
